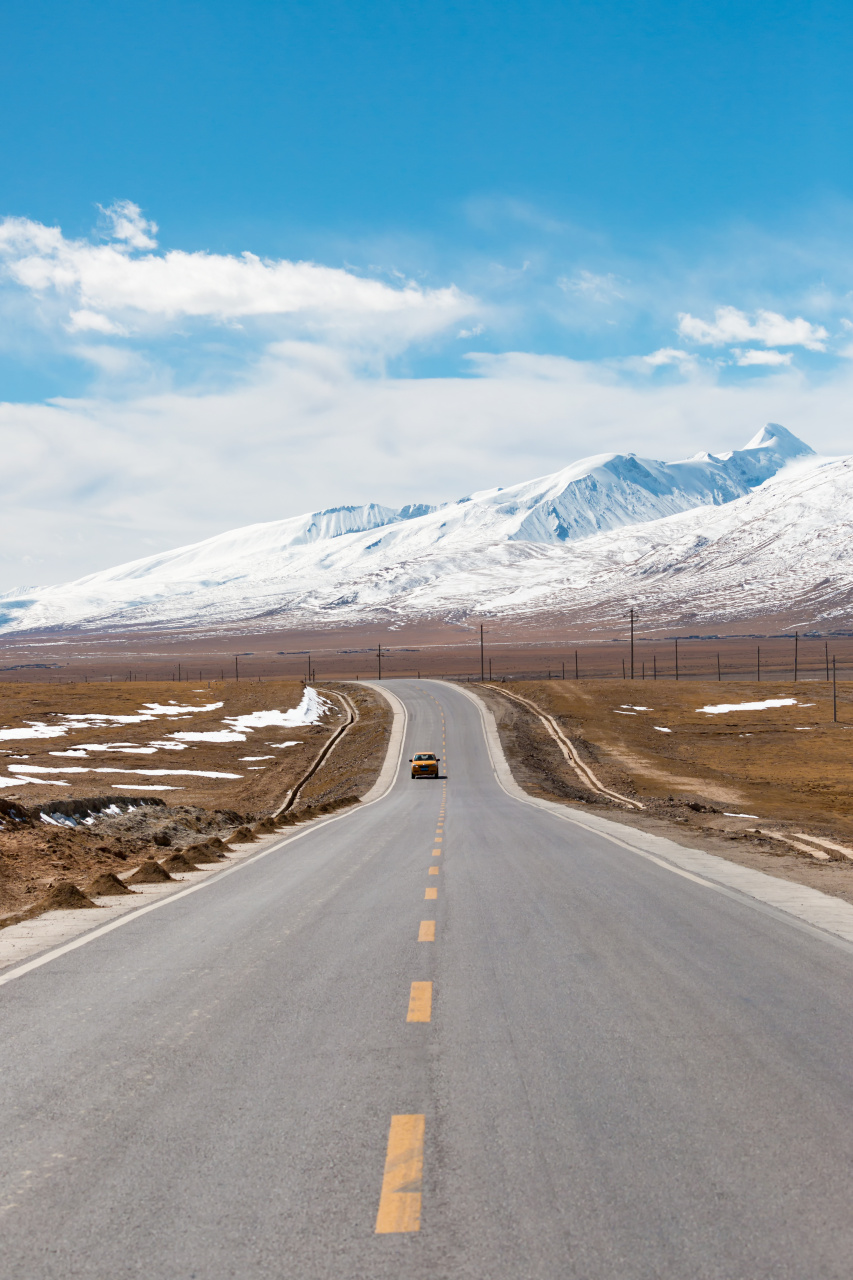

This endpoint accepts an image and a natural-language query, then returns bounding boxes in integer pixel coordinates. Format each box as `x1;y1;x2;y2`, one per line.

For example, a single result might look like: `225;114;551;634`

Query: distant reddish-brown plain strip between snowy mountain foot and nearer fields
0;612;853;686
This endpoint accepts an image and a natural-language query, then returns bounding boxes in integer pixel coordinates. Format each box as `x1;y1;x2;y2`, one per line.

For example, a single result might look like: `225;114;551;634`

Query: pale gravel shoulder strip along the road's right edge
459;685;853;947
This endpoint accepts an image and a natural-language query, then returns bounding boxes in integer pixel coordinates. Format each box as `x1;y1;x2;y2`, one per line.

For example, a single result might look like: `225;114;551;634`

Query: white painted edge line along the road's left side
0;681;409;987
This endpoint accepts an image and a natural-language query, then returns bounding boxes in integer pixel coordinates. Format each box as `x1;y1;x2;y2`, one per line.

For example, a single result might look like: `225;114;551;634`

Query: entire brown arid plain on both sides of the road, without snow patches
0;617;853;914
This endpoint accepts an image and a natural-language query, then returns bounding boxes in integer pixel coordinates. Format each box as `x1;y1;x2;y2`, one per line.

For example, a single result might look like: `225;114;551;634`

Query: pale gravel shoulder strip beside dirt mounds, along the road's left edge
0;681;406;986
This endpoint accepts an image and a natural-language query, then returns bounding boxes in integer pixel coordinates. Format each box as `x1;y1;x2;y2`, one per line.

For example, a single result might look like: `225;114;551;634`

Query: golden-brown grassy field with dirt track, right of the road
473;680;853;902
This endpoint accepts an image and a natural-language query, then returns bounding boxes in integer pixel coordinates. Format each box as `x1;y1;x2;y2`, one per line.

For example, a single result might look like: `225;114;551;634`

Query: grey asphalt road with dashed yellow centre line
0;682;853;1280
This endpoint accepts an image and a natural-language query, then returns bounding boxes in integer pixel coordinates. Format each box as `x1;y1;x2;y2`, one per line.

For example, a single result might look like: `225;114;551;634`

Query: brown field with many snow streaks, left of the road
0;681;392;927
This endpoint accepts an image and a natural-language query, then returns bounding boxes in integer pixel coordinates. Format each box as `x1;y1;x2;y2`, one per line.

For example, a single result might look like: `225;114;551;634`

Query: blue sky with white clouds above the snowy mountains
0;0;853;588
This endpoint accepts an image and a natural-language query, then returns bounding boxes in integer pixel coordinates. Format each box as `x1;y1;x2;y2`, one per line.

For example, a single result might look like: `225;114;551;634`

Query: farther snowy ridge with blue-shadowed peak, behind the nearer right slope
0;424;824;631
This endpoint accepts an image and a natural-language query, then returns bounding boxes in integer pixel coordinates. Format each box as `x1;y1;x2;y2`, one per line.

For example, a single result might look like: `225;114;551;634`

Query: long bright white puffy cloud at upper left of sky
0;201;475;340
